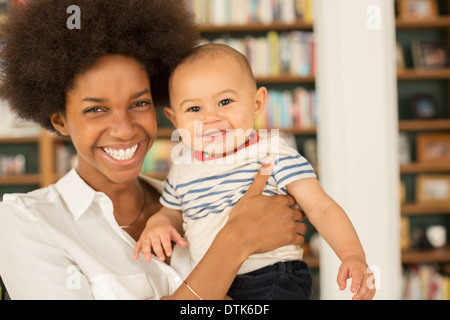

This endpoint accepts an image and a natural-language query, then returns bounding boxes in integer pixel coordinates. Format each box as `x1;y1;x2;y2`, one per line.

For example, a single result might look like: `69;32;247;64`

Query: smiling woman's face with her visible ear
52;55;157;188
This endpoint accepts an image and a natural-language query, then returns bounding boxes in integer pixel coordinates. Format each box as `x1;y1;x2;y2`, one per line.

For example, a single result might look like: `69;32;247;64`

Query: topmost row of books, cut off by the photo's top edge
186;0;313;25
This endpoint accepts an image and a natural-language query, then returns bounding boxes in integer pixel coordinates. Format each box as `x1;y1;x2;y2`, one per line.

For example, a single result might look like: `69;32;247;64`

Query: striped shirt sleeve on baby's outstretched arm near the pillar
272;138;317;193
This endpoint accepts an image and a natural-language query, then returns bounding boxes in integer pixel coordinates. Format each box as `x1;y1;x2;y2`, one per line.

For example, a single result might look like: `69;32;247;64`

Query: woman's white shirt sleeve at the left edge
0;201;93;300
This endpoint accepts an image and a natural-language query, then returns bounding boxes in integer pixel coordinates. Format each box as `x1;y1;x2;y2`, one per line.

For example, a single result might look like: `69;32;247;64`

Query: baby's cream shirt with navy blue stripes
160;136;316;274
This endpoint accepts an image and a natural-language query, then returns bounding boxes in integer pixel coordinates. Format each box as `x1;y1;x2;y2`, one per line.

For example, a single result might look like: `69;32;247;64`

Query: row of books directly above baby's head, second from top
201;31;316;77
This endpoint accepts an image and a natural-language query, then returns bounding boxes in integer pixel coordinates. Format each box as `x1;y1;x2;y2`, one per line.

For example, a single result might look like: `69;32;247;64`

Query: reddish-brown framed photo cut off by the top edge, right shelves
397;0;439;20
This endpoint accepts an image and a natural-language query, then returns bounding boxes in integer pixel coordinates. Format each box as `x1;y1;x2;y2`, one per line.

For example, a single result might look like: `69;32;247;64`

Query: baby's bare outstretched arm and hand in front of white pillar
287;178;375;299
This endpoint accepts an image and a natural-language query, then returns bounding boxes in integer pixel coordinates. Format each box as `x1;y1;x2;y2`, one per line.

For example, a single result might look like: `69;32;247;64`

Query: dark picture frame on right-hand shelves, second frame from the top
411;40;449;69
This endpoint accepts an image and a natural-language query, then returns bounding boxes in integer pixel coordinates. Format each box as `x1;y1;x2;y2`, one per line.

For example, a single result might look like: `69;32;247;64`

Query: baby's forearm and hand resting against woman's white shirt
134;207;187;261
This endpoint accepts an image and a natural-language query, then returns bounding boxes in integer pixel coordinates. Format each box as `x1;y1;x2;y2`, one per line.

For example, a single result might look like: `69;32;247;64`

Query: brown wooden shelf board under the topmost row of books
199;22;313;33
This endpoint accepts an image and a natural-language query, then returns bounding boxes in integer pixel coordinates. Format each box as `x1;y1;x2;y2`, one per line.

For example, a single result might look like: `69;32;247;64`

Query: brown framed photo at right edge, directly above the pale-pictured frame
416;133;450;164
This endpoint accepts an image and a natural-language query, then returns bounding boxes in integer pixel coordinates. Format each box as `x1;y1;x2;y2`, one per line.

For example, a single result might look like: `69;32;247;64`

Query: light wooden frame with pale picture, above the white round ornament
416;175;450;204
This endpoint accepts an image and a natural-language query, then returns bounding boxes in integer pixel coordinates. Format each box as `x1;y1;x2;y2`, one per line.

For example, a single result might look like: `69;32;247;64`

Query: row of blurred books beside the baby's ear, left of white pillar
255;87;317;129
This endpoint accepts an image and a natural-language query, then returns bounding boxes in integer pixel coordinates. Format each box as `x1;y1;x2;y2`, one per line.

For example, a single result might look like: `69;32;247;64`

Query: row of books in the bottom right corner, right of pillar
402;264;450;300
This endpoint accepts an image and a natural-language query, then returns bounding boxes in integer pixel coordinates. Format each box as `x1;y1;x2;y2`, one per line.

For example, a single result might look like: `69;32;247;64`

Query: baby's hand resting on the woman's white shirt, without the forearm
134;223;187;262
